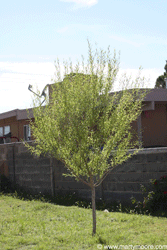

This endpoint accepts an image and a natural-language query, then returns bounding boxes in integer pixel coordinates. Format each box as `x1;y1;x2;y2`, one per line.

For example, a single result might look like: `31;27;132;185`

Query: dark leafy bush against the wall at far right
131;175;167;215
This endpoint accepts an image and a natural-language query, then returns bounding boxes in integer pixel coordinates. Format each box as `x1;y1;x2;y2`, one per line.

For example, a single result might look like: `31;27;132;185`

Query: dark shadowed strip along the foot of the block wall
0;176;167;217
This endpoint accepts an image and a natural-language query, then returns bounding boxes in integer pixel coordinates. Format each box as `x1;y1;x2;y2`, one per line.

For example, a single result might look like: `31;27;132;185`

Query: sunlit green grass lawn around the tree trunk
0;195;167;250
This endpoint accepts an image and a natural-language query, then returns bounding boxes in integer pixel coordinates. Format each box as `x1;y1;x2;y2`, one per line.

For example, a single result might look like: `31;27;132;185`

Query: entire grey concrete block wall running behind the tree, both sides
0;142;167;203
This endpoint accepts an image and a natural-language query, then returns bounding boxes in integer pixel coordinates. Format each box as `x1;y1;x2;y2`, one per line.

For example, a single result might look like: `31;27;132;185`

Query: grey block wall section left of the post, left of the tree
0;142;51;194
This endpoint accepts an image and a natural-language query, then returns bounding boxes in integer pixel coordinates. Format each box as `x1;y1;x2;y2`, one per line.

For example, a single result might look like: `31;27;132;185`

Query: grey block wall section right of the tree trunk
103;147;167;203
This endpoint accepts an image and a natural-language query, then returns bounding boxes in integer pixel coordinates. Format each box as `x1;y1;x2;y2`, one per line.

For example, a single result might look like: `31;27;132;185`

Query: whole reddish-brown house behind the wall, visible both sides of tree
0;84;167;147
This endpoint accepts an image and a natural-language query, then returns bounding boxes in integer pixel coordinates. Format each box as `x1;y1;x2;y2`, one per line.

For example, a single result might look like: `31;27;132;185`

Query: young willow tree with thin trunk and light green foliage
26;42;149;235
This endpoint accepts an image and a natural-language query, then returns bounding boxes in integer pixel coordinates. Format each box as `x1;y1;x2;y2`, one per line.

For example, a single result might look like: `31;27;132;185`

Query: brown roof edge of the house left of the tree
0;108;34;120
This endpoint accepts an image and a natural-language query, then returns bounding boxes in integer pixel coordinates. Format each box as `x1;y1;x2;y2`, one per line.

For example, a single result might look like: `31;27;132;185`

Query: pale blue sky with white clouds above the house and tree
0;0;167;113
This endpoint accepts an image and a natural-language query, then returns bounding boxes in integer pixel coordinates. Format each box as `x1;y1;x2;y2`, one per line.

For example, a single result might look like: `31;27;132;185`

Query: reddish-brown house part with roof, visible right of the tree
138;88;167;147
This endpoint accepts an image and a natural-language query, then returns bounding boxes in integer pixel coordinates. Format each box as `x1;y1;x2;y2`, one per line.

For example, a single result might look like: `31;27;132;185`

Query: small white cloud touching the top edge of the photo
60;0;98;10
